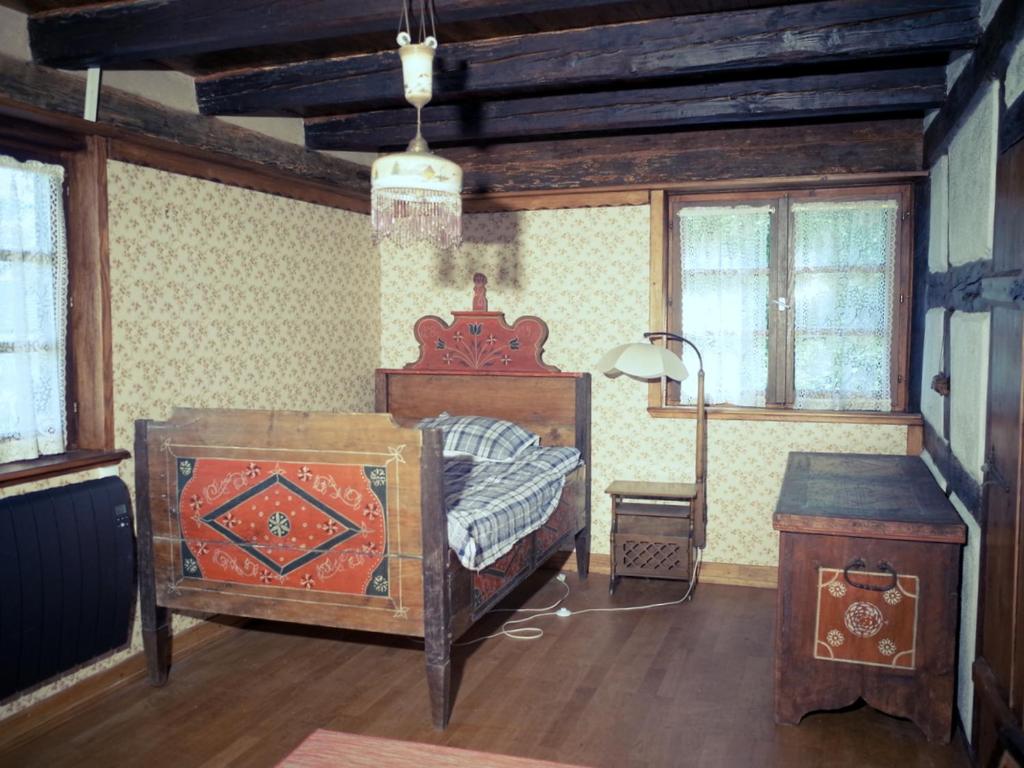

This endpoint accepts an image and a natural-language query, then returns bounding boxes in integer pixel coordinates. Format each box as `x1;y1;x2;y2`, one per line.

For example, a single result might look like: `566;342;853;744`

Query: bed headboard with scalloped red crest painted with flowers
376;274;590;459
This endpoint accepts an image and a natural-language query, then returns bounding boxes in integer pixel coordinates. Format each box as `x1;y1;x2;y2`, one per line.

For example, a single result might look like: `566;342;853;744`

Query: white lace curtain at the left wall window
0;155;68;463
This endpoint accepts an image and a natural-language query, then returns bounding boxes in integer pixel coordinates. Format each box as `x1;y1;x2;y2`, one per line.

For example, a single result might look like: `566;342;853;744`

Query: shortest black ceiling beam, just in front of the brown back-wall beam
306;67;946;152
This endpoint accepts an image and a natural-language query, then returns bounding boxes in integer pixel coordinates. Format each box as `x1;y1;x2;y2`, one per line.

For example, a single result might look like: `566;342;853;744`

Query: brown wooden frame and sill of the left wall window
0;121;129;486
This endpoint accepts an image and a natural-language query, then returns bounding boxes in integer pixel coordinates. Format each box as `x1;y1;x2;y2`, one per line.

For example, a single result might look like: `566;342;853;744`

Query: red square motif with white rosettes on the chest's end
814;568;920;670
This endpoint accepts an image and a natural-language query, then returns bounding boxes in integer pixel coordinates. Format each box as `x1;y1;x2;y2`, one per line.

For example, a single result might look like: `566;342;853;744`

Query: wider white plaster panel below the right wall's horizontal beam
949;312;989;483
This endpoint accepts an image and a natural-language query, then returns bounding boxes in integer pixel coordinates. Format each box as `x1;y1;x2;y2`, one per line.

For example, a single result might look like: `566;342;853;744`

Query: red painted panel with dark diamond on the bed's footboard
176;457;388;597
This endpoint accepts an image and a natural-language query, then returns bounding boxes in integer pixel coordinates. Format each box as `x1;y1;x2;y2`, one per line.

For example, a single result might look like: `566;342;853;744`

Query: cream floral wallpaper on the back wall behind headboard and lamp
381;206;906;565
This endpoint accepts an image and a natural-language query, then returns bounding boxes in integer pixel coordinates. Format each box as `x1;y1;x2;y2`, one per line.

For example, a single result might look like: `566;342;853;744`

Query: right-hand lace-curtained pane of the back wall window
793;201;897;411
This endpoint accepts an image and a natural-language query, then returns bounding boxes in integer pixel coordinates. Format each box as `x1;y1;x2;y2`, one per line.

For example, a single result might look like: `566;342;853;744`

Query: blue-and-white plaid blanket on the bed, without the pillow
444;446;580;570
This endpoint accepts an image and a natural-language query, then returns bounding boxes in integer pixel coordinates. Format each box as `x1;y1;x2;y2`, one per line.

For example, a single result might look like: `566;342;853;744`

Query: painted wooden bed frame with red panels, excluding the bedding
135;279;590;728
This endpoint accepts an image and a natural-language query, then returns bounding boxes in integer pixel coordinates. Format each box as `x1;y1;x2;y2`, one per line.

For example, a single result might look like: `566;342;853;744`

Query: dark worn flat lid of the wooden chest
772;453;967;544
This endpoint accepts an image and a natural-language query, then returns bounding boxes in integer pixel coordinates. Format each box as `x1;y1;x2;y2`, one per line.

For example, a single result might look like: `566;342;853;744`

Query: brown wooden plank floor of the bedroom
6;572;968;768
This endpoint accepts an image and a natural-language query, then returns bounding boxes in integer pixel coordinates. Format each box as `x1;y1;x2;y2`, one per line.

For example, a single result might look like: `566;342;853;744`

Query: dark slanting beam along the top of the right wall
925;0;1024;168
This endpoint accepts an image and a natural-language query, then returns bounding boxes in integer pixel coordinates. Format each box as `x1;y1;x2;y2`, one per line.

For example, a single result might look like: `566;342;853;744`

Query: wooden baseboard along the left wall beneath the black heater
0;616;247;752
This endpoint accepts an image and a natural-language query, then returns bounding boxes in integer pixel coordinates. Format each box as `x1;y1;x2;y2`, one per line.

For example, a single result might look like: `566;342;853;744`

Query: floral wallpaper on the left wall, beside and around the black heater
0;162;380;718
